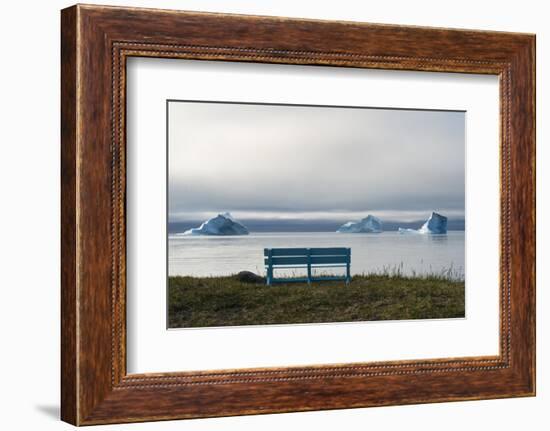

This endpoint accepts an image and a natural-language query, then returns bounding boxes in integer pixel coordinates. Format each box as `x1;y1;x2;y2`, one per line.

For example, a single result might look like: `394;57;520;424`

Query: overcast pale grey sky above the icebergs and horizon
168;102;465;222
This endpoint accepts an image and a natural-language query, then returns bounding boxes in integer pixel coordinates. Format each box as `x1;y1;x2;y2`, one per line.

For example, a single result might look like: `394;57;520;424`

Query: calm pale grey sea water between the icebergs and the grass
168;231;465;278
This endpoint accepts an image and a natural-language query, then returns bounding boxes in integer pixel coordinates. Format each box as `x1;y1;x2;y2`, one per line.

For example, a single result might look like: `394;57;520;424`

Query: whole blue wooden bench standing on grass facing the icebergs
264;247;351;286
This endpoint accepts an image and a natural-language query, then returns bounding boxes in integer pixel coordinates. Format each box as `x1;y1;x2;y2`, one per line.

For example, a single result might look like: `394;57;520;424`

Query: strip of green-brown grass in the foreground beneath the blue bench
168;271;464;328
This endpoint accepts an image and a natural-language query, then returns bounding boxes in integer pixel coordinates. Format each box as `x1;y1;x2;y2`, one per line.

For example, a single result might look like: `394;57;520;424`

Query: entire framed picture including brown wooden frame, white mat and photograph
61;5;535;425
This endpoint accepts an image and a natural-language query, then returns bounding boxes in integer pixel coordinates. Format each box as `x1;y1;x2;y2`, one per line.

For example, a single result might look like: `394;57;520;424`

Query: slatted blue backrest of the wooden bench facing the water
264;247;351;266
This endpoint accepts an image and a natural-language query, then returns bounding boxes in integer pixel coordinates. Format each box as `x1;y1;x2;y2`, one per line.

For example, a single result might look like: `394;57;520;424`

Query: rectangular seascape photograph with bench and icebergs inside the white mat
166;100;466;328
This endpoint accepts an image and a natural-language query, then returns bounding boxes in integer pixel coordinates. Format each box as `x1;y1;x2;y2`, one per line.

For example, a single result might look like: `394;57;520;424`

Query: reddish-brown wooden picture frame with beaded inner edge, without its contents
61;5;535;425
